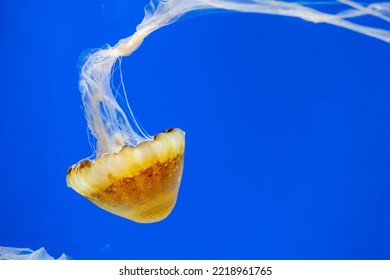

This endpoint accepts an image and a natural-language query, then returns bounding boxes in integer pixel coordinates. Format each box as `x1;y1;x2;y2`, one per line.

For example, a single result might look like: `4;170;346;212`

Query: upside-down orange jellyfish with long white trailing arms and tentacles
66;0;390;223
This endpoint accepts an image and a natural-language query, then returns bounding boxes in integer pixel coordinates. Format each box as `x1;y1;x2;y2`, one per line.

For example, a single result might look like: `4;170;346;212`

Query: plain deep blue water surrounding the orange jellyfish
0;0;390;259
